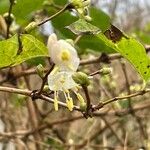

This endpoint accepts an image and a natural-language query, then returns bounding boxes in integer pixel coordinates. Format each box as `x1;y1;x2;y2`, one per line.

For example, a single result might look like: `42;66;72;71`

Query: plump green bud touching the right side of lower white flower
72;72;90;86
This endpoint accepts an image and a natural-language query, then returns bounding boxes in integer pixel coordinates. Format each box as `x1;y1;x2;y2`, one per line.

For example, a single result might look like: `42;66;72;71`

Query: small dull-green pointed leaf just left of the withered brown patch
66;19;100;35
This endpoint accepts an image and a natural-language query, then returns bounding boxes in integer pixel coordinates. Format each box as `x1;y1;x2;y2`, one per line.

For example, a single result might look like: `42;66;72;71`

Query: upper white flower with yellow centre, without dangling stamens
47;34;80;71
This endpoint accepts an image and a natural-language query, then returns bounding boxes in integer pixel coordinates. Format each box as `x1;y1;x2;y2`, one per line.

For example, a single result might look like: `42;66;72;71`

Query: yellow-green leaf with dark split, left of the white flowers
0;34;48;68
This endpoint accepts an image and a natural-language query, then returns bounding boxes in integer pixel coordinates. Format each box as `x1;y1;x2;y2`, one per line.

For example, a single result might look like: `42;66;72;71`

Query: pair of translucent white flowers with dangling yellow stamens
47;34;84;111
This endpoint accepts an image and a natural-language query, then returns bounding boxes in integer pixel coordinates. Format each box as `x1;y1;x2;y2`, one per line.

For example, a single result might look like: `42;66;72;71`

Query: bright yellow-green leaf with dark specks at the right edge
97;33;150;81
